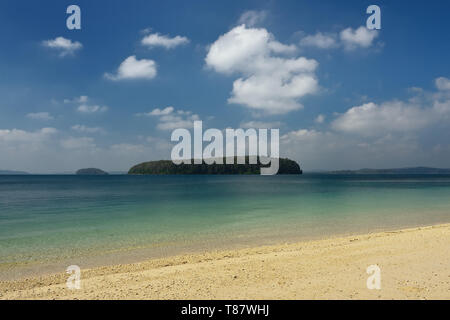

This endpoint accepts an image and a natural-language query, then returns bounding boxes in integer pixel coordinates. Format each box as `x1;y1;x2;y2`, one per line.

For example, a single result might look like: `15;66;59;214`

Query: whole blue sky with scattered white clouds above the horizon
0;0;450;173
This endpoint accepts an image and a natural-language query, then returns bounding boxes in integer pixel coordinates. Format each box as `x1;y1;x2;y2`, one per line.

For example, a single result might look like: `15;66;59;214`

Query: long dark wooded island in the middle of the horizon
128;157;302;175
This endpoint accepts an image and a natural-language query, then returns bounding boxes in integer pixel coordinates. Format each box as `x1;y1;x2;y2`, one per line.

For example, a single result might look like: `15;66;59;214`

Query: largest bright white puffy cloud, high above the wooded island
205;25;318;114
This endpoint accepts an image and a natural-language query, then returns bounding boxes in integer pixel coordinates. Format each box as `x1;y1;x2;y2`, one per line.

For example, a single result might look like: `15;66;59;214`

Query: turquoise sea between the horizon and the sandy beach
0;174;450;278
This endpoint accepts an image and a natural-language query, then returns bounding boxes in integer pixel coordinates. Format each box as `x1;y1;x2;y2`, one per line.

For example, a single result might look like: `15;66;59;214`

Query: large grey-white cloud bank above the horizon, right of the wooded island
280;79;450;170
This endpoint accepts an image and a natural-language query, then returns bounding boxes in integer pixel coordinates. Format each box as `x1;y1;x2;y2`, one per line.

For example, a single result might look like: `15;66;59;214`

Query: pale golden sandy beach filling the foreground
0;224;450;299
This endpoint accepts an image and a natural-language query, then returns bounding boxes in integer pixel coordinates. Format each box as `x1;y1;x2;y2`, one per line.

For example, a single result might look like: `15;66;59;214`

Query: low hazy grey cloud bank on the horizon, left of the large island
0;128;172;173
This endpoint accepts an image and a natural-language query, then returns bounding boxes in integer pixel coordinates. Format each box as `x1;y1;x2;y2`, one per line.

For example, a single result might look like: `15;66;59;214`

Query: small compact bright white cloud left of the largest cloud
104;56;157;81
